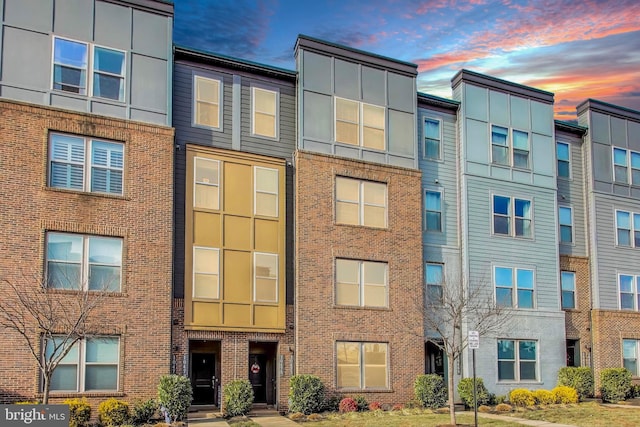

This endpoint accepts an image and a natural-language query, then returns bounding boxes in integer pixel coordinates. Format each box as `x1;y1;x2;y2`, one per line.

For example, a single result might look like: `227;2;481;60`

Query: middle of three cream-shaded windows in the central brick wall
336;259;389;307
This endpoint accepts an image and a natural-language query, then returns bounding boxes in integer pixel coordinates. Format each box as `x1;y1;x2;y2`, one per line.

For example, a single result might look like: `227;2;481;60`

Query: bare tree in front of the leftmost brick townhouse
0;274;109;404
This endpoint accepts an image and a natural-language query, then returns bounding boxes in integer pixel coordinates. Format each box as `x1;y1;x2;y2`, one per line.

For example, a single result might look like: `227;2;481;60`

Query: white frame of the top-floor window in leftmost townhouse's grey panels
50;36;127;103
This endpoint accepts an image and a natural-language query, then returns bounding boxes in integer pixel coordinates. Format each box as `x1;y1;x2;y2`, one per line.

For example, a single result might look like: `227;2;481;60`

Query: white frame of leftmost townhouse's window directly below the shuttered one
45;231;124;293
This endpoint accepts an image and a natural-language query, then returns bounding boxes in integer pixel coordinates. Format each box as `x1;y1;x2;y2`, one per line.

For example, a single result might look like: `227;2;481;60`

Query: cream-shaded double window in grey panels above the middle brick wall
335;98;385;150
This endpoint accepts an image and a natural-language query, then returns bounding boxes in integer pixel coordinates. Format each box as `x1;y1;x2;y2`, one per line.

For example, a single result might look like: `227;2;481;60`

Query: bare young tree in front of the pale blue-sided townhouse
424;271;512;425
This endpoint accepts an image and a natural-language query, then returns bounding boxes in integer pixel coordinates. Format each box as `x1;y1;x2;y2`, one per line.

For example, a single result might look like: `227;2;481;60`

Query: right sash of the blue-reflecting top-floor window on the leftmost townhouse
93;46;125;101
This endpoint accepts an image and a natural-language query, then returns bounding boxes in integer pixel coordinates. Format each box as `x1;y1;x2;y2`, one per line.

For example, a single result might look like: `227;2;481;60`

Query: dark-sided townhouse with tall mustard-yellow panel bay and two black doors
172;46;296;407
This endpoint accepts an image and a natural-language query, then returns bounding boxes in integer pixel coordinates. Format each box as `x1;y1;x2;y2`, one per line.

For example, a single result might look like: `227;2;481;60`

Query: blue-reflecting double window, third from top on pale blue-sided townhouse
493;267;535;308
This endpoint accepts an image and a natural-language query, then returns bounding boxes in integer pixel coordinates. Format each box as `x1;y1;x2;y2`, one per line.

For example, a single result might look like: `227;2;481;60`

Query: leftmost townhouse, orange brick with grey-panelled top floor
0;0;174;403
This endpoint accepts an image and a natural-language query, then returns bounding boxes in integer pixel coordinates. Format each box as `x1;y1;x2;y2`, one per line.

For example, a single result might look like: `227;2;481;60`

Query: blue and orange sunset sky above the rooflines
174;0;640;120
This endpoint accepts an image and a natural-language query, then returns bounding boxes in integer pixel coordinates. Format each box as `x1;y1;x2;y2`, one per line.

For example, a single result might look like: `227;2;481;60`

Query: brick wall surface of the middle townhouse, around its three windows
295;151;424;404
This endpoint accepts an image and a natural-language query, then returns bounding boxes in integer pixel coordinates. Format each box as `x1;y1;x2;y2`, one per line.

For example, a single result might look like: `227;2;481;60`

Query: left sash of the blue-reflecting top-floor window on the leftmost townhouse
53;37;88;95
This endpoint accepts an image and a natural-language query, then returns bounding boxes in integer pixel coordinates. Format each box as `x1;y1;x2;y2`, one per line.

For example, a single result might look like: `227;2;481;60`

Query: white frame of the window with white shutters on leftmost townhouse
47;132;126;196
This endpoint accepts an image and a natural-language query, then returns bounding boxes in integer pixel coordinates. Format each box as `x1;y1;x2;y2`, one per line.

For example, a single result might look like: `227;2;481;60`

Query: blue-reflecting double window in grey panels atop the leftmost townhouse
53;37;126;101
